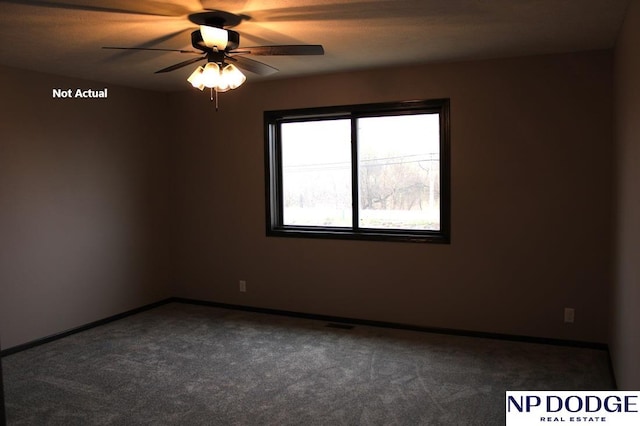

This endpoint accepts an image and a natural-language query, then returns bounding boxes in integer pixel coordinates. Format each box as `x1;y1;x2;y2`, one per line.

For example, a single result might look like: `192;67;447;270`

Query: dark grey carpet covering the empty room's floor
2;303;614;426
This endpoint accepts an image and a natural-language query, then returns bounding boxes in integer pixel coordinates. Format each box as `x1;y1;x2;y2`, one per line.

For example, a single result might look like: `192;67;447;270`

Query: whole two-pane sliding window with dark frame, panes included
264;99;450;243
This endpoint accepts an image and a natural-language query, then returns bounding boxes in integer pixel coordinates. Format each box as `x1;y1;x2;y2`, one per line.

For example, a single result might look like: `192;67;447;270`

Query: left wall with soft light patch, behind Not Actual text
0;67;170;349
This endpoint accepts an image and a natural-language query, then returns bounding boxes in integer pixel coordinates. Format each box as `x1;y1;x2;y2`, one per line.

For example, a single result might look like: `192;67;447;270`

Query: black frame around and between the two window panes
264;98;451;244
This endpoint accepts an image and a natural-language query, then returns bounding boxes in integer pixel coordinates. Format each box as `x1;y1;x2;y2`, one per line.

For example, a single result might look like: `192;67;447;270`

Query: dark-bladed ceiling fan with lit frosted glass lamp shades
103;10;324;100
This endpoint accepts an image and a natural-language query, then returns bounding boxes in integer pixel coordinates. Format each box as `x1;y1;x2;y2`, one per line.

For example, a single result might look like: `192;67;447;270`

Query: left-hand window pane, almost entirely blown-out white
281;120;352;226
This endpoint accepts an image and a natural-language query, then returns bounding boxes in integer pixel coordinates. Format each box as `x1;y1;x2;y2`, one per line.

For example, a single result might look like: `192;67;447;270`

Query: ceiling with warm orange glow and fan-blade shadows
0;0;629;91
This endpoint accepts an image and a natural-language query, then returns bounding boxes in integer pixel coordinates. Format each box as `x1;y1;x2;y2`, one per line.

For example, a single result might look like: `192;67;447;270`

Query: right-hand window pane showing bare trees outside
358;114;440;231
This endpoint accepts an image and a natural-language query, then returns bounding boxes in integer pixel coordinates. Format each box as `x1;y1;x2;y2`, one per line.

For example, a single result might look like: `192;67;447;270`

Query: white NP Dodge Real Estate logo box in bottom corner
506;391;640;426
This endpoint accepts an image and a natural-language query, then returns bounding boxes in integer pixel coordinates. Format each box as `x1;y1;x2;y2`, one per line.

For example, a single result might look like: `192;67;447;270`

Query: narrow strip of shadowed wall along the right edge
611;0;640;390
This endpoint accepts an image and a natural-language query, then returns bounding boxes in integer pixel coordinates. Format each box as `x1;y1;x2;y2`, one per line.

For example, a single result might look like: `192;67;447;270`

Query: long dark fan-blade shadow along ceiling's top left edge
1;0;191;16
